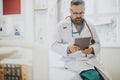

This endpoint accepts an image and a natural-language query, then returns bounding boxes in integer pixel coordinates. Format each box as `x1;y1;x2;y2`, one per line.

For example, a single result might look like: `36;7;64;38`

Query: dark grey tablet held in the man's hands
74;37;91;50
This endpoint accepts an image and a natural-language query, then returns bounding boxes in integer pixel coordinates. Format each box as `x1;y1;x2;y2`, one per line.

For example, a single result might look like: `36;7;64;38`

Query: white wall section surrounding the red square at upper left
0;0;34;42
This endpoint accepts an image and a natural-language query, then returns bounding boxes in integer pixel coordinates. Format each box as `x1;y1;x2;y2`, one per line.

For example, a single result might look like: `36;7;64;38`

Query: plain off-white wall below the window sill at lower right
101;47;120;80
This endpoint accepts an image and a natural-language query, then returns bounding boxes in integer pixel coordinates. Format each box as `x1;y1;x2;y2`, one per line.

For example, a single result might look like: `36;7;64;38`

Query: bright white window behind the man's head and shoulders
60;0;120;46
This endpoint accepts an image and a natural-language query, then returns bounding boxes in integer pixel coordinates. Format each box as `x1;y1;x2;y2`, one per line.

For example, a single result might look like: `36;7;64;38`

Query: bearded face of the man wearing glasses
70;5;85;24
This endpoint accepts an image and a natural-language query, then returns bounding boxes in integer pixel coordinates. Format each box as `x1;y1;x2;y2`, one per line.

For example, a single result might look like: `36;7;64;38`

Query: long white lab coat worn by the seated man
52;18;112;80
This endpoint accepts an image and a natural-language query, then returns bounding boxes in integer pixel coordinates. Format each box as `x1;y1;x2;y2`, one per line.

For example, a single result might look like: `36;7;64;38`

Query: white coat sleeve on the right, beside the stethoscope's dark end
89;24;101;56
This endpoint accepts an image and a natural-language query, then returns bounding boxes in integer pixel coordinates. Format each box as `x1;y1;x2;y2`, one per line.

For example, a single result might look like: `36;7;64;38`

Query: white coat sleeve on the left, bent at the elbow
51;24;68;56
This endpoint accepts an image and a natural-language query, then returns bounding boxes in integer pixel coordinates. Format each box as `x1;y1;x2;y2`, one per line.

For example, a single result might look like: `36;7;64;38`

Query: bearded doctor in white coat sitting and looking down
52;0;112;80
